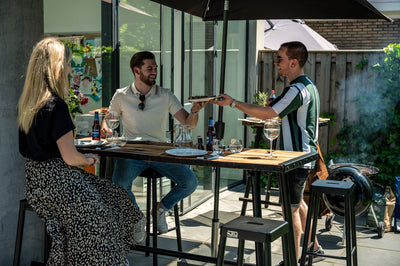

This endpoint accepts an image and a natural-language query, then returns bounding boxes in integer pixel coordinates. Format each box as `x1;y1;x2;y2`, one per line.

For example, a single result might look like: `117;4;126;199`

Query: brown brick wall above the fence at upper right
305;19;400;50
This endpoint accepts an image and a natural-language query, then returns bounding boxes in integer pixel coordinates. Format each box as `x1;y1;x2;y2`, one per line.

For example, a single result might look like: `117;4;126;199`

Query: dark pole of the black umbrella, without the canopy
214;0;229;139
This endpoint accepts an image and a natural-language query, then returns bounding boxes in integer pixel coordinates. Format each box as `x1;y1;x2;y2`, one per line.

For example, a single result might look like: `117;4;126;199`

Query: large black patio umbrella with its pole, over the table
151;0;392;139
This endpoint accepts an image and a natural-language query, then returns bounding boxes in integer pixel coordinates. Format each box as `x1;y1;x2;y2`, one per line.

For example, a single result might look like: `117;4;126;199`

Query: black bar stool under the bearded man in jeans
139;168;182;265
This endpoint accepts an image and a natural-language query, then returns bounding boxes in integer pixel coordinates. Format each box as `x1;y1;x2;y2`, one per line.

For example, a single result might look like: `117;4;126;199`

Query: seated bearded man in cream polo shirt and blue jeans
101;51;205;243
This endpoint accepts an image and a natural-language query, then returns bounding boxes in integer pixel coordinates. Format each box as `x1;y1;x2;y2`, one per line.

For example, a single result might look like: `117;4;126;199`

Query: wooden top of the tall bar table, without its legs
78;141;318;173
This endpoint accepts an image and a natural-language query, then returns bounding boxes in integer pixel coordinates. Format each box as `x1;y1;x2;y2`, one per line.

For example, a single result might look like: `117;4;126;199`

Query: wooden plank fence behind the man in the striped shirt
253;50;385;155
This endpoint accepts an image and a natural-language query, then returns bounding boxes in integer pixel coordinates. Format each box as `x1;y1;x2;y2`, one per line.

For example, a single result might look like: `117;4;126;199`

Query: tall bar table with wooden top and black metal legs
78;141;318;265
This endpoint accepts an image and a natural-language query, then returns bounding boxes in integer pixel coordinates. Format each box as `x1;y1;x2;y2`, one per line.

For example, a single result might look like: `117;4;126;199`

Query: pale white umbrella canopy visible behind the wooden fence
264;19;337;50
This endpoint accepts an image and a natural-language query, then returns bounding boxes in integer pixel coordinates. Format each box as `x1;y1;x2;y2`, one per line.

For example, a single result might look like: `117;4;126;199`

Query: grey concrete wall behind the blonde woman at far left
0;0;43;265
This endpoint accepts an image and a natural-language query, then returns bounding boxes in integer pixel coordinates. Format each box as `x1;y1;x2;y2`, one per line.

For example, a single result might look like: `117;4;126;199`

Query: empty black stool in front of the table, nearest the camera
217;216;289;266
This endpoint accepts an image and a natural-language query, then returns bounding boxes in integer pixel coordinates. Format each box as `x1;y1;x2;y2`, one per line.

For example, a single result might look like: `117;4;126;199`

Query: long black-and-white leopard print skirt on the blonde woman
25;158;141;266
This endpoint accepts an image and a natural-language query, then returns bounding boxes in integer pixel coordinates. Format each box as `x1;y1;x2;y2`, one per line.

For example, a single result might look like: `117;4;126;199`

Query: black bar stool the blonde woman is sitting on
13;199;51;266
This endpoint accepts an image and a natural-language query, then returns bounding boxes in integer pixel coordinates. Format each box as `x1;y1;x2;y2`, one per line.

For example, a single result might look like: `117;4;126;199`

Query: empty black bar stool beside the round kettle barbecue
300;179;357;266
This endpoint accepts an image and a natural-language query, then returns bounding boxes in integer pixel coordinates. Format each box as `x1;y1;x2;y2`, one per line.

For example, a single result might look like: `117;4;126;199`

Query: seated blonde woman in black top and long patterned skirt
18;38;143;265
